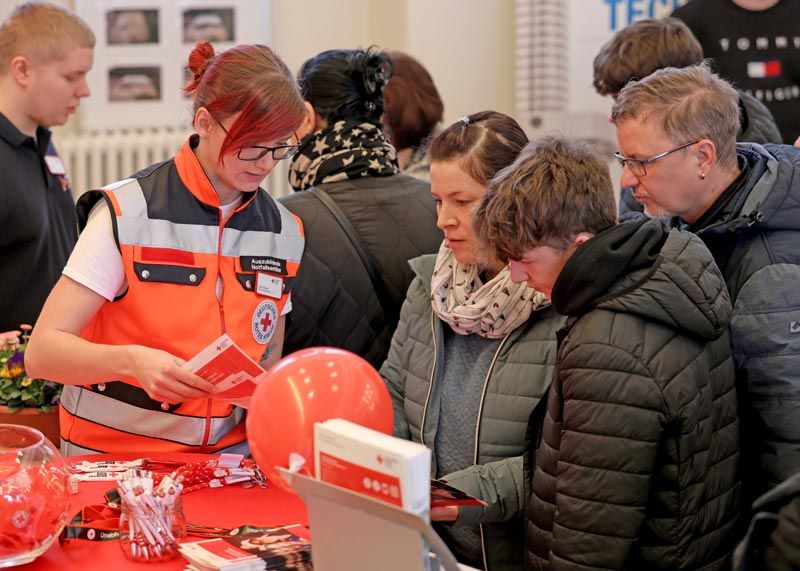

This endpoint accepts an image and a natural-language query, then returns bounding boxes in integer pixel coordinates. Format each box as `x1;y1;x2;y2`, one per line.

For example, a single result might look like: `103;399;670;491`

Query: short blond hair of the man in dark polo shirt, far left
0;2;95;71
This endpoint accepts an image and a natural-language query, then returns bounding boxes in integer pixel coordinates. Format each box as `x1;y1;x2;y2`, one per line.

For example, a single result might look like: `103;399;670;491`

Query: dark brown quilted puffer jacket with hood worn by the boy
525;220;739;570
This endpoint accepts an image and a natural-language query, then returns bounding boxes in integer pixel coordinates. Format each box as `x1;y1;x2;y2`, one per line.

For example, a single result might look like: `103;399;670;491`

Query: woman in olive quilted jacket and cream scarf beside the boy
381;111;563;571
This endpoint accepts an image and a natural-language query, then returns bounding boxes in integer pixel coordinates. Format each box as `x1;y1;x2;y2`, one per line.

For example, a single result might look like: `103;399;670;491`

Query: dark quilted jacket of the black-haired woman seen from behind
280;174;444;369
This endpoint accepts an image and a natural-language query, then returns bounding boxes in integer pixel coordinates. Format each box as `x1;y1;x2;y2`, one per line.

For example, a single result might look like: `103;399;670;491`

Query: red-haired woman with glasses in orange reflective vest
26;42;305;455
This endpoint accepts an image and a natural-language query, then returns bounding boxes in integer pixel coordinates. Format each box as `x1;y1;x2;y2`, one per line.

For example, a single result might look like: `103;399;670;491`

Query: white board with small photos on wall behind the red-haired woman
75;0;270;131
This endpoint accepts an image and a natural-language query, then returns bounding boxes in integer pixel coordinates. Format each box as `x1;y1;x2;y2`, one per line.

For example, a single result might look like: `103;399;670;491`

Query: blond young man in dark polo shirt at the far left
0;2;95;331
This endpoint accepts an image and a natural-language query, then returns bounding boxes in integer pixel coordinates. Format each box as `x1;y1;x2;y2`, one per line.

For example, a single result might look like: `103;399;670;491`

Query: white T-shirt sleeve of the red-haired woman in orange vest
64;200;125;301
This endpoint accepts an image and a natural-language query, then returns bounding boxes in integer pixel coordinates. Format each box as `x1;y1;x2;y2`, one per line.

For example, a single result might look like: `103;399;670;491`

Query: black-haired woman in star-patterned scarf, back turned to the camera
281;50;442;368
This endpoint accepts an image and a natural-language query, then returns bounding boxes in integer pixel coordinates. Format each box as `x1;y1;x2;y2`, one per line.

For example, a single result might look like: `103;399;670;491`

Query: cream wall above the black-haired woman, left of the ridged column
272;0;514;123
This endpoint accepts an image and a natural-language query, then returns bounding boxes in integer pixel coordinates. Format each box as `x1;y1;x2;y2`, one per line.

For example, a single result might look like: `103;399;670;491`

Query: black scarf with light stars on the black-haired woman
289;121;400;190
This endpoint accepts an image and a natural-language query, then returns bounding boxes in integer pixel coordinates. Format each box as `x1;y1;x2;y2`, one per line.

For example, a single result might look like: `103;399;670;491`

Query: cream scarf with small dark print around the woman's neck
431;242;550;339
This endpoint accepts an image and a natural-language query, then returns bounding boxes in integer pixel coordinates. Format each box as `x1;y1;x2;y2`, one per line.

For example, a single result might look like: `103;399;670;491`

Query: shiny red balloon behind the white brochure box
247;347;393;491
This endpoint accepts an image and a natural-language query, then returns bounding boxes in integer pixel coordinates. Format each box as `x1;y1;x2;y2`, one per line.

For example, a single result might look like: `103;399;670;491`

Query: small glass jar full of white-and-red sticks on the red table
119;495;186;563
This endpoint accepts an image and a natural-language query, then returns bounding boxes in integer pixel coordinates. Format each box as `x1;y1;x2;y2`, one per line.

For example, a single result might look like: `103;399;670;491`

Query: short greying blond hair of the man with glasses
611;62;739;169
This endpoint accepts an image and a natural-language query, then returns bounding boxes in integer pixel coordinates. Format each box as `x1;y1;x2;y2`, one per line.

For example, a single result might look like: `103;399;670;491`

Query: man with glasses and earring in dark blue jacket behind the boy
612;60;800;504
